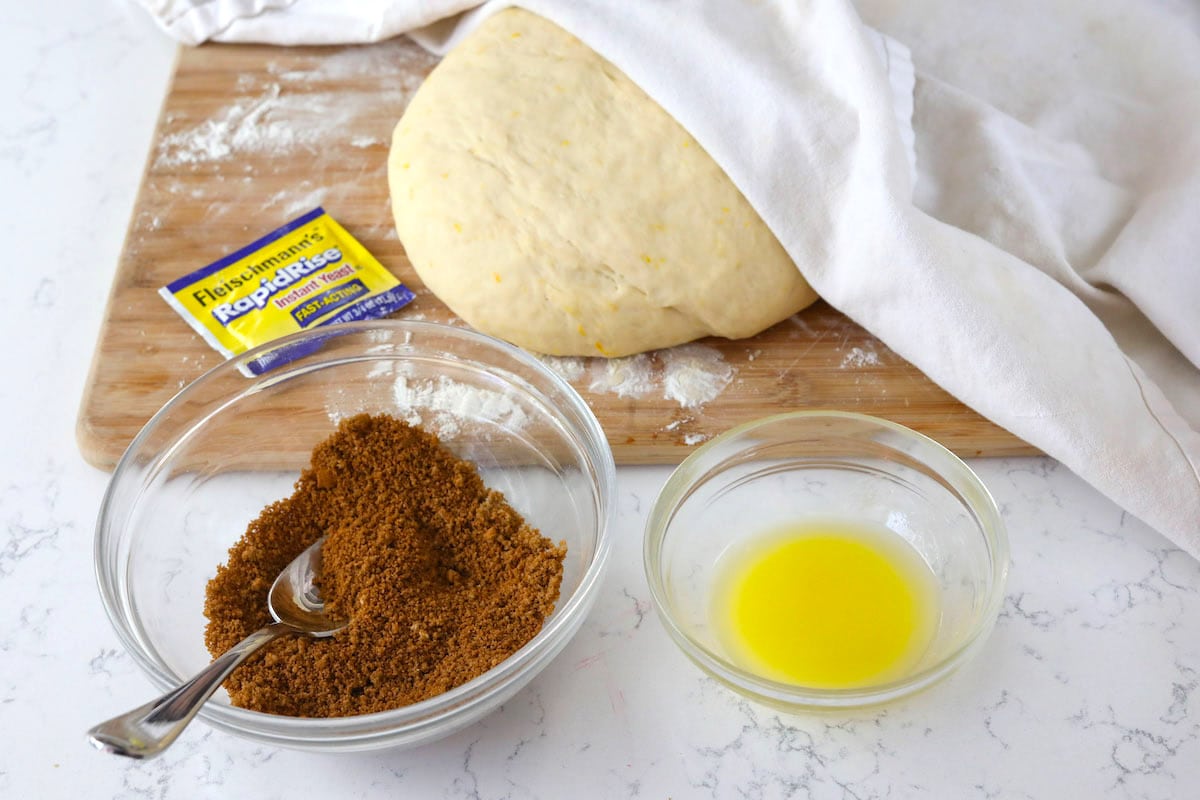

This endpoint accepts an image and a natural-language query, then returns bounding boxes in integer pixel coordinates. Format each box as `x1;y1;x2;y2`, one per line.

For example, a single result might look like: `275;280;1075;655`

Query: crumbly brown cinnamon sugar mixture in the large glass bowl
204;415;565;717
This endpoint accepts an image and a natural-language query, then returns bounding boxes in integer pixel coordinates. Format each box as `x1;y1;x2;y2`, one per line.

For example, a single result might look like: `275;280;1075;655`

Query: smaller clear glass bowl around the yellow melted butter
643;411;1008;710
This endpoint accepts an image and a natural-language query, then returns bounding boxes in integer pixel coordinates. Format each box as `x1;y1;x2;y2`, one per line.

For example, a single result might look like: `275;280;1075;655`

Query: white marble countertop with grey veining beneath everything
7;0;1200;799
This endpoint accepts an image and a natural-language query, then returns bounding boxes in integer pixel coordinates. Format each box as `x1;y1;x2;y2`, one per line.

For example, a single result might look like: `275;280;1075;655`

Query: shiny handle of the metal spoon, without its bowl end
88;622;299;758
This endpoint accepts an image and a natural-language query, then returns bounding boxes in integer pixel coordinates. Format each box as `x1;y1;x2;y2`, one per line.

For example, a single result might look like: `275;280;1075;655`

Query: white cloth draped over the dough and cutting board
133;0;1200;558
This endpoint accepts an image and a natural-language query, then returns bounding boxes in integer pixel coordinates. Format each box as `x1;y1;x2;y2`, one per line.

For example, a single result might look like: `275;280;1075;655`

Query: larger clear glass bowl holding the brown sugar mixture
95;320;616;751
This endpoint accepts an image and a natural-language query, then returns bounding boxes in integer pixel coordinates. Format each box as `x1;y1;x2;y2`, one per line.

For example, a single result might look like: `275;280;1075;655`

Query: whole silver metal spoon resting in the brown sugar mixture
88;536;346;758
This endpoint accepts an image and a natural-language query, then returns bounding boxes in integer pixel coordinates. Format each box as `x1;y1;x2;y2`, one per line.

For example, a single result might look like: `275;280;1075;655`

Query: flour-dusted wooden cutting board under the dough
78;40;1036;469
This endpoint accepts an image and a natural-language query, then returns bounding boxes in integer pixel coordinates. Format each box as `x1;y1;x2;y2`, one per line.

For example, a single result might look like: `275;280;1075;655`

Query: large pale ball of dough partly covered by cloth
388;10;816;356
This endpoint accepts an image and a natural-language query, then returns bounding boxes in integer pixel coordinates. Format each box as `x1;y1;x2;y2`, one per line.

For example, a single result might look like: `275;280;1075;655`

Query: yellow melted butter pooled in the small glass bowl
712;519;940;688
